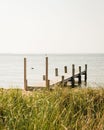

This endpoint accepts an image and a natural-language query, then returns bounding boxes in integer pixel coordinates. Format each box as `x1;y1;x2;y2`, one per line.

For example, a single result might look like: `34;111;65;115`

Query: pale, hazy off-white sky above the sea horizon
0;0;104;54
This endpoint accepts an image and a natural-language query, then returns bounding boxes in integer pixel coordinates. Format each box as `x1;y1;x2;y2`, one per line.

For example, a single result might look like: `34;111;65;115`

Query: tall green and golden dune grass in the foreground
0;88;104;130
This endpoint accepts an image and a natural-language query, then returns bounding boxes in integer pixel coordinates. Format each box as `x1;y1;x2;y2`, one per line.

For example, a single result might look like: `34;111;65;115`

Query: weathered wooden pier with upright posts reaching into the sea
24;57;87;91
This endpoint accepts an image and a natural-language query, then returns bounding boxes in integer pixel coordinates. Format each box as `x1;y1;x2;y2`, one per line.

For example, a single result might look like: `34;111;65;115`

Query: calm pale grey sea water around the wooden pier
0;54;104;88
